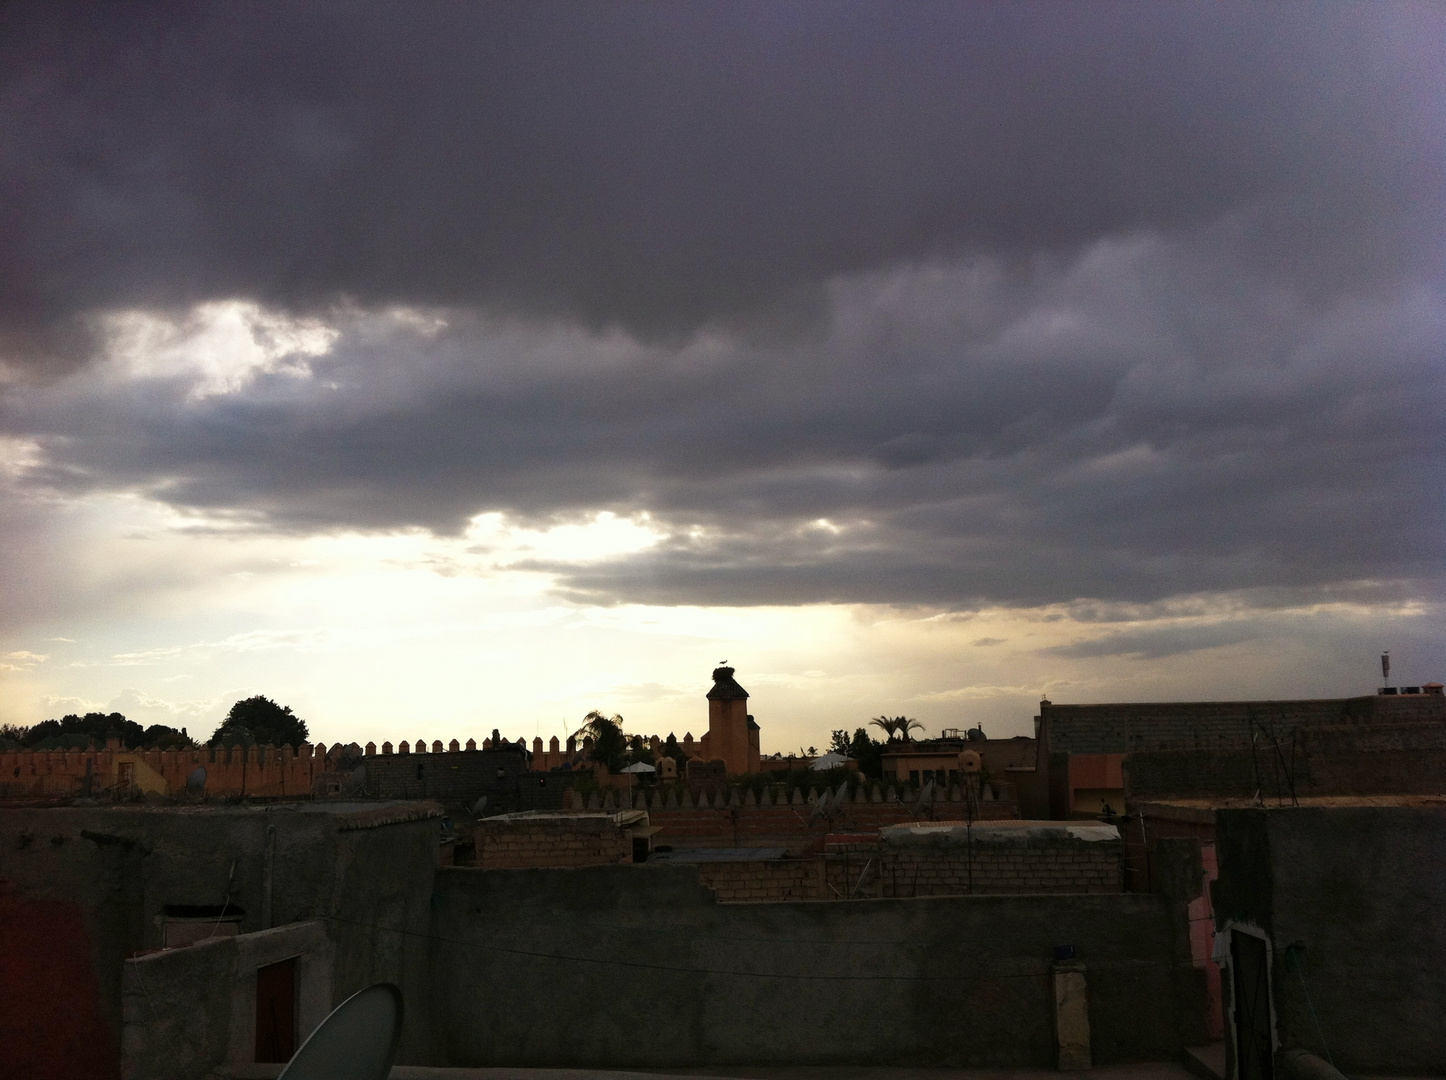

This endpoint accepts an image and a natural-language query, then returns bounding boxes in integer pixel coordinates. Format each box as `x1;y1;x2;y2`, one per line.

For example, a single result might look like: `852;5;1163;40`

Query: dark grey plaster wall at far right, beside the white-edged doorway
1213;807;1446;1076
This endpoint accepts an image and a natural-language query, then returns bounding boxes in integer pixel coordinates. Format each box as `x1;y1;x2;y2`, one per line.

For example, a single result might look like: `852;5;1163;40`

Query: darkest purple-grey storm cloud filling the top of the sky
0;3;1446;370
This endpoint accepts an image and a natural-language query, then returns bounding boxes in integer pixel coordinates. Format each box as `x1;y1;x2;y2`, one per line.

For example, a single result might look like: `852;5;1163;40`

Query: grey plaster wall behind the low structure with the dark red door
0;804;440;1076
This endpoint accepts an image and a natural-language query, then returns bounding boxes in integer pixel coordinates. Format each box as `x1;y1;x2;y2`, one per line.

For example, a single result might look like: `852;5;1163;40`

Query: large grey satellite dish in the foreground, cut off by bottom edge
278;983;402;1080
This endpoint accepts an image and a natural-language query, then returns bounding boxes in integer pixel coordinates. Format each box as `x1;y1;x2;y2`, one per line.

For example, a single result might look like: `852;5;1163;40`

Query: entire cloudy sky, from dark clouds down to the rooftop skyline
0;0;1446;750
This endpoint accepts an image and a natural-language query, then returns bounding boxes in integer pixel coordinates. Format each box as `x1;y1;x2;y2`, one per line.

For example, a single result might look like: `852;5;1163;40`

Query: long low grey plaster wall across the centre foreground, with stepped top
432;860;1205;1068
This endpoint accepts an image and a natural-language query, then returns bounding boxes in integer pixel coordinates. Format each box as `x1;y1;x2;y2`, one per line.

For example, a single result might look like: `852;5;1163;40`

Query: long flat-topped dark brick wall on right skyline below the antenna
1040;694;1446;753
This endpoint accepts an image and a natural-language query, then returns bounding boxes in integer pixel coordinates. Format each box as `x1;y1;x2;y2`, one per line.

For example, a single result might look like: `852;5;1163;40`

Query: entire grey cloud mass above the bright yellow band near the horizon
0;3;1446;621
